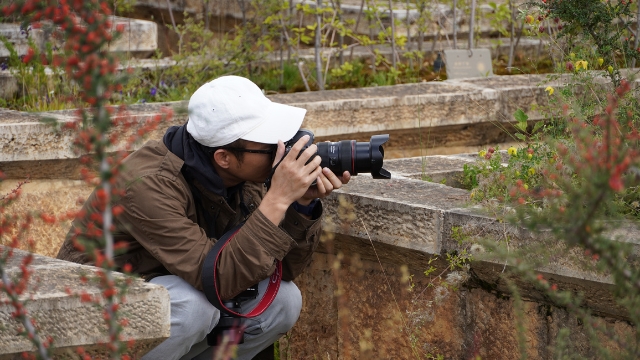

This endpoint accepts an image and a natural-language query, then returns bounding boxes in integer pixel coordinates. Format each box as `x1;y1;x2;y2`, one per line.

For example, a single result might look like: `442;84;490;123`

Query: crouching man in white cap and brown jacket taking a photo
58;76;350;360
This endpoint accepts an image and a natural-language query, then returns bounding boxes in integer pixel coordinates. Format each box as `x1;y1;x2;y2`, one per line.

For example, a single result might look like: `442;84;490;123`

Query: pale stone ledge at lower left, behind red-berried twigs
0;247;170;360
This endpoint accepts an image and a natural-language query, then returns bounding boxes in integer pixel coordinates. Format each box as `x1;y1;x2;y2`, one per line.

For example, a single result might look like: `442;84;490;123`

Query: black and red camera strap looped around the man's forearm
202;222;282;318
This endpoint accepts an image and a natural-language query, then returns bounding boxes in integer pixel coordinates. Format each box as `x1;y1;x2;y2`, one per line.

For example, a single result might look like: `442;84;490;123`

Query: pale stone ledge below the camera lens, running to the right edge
326;155;640;319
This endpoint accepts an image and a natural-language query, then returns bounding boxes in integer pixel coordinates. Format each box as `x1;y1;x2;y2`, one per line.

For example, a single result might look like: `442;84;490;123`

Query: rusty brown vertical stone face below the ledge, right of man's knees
280;249;633;360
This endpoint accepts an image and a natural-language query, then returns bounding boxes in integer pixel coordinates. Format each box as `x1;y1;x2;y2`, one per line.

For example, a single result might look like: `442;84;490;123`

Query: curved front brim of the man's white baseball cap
240;102;307;144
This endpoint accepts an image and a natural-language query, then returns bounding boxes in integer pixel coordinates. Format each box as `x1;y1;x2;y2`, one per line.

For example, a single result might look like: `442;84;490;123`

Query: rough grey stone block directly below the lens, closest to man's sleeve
326;175;468;254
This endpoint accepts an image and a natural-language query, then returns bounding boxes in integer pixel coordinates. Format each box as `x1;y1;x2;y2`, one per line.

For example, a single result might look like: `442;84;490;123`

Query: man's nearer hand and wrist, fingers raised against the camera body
258;135;322;225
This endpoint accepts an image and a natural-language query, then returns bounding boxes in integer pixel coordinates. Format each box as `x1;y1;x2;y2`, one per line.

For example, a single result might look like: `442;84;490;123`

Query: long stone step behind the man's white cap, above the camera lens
0;71;636;178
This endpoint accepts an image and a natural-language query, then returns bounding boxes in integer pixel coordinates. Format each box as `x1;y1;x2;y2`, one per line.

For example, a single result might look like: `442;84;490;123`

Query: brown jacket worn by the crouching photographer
58;141;322;299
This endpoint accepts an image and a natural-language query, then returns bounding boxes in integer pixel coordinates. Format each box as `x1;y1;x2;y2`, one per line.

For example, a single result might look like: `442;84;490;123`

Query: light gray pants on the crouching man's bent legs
142;275;302;360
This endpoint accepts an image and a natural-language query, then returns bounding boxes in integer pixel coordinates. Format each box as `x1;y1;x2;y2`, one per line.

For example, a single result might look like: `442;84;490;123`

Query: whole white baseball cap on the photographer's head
187;76;307;147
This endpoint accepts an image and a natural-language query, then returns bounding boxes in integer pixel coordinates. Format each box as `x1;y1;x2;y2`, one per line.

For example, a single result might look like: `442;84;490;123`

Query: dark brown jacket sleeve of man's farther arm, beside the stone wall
280;202;323;281
